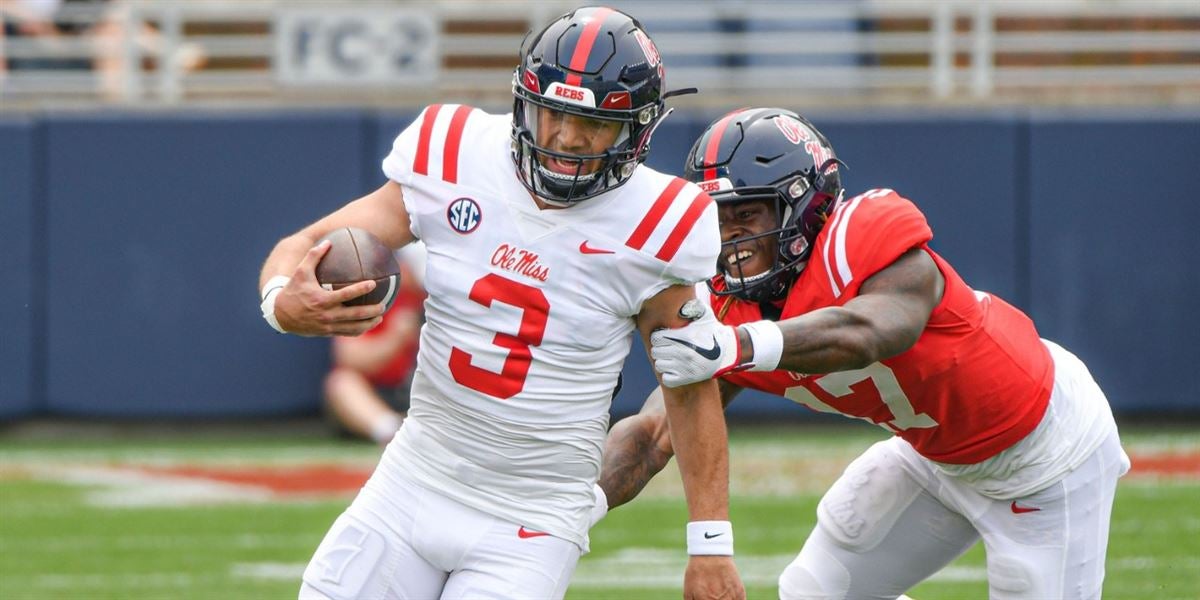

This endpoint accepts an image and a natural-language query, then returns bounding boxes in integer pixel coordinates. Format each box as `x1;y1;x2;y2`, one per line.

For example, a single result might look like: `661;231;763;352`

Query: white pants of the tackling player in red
779;344;1129;600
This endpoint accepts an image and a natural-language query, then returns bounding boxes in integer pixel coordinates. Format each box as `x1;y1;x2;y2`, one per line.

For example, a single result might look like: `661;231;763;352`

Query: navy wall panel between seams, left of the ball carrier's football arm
41;113;368;418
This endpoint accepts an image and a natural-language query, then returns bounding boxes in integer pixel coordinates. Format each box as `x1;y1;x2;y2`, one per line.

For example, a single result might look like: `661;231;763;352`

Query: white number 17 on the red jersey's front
784;362;937;432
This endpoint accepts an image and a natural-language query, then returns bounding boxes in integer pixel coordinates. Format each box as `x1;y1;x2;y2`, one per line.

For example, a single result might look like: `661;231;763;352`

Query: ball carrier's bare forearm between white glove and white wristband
664;380;730;521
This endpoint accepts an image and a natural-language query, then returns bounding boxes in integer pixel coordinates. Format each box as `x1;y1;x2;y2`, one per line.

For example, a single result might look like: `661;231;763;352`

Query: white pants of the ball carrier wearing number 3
300;482;580;600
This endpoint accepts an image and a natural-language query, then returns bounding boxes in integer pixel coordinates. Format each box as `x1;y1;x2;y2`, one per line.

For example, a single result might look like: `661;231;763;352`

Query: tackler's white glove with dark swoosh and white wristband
650;311;784;388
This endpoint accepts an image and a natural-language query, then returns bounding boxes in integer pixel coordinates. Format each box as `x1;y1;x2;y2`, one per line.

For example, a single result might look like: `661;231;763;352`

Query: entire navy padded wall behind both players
0;110;1200;420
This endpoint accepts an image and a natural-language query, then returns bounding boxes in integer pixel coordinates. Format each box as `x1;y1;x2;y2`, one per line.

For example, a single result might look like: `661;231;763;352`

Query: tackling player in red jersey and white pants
600;108;1129;599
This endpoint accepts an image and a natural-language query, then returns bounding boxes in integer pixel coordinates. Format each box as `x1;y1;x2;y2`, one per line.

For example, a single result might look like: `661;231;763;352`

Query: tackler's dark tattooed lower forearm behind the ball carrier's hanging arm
600;379;742;510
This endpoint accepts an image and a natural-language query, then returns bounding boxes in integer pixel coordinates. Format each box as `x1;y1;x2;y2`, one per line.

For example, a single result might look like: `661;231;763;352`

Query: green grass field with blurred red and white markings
0;426;1200;600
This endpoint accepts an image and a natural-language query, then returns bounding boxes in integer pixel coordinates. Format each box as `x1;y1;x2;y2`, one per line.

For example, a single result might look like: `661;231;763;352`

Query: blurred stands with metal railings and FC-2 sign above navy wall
0;0;1200;108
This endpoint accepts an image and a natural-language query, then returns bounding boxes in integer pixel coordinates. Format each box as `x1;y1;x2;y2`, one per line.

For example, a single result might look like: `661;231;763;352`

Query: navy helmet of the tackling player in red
684;108;844;302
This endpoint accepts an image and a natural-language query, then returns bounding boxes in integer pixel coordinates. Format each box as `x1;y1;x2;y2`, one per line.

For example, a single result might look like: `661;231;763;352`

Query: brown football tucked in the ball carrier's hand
317;227;400;307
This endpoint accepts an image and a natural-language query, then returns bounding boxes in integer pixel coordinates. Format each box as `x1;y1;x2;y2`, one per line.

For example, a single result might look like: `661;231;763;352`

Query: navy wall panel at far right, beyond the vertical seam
1028;113;1200;413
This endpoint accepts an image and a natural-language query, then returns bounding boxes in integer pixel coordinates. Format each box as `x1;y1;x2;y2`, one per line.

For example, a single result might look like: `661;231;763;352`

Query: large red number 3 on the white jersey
450;274;550;398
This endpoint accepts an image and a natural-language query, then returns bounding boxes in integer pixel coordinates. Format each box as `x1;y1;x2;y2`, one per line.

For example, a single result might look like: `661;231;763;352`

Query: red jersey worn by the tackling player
713;190;1054;464
